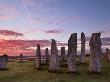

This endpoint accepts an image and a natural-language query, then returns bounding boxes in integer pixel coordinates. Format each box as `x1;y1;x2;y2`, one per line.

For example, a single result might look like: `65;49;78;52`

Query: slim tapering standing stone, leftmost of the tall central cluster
36;44;41;69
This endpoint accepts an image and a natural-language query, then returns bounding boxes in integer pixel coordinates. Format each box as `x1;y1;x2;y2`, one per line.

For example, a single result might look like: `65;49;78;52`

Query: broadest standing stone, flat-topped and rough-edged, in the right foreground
89;33;102;73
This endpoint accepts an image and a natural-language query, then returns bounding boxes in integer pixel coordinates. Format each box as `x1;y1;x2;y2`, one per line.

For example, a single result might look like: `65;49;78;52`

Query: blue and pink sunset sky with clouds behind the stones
0;0;110;55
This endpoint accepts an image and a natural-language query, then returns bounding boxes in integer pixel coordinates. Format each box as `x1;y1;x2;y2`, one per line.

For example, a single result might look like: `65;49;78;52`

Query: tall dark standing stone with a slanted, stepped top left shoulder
68;33;77;73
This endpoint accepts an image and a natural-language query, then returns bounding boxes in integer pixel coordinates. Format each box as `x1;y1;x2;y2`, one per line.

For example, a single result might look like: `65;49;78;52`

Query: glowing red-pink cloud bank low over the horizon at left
0;40;50;55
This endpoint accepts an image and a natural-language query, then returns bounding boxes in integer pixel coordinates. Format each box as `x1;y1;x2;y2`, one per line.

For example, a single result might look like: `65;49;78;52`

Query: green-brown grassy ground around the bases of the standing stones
0;59;110;82
